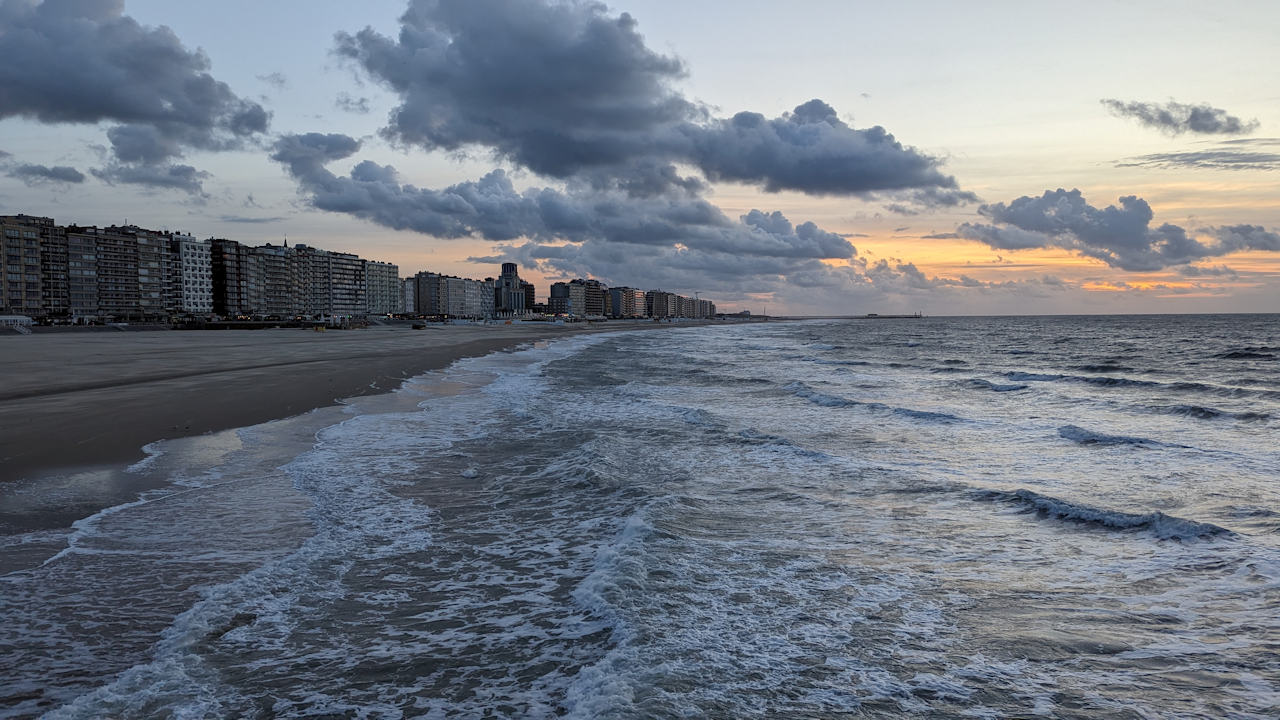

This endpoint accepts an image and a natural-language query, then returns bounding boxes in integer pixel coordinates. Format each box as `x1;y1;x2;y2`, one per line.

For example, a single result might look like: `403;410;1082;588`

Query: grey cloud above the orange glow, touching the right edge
956;188;1280;272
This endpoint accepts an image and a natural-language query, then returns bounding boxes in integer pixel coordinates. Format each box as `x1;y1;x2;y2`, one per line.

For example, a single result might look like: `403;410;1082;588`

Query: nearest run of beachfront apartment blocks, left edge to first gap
0;215;402;322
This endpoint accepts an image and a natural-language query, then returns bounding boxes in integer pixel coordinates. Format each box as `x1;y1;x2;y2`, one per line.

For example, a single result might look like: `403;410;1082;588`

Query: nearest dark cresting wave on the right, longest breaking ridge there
972;489;1235;541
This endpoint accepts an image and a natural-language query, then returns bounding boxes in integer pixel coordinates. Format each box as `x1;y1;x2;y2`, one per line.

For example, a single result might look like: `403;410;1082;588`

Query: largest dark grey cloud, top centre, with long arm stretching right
337;0;956;196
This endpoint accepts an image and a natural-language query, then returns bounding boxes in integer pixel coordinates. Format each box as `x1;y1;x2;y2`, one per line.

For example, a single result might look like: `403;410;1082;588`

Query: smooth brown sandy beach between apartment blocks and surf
0;323;634;480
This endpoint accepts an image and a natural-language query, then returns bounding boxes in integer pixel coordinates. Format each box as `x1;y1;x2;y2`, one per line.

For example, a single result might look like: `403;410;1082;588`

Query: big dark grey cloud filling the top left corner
0;0;269;188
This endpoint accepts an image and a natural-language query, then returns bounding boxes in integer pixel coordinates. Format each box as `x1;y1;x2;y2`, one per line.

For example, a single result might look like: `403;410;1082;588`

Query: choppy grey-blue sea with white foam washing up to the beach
0;315;1280;720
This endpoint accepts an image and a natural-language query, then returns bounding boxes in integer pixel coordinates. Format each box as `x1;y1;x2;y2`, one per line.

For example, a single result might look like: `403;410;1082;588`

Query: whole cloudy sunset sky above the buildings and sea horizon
0;0;1280;315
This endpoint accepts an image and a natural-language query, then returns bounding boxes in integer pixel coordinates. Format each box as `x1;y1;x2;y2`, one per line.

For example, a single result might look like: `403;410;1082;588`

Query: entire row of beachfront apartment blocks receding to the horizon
0;215;716;322
